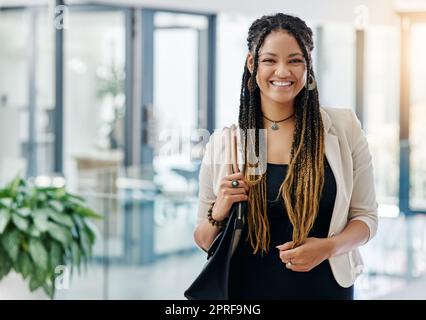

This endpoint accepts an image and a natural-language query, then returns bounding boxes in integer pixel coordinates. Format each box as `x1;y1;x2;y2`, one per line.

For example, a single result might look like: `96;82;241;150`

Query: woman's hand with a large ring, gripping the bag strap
212;172;249;221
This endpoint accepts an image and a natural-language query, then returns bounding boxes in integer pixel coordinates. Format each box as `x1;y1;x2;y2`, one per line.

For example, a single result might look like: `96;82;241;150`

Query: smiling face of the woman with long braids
247;30;306;109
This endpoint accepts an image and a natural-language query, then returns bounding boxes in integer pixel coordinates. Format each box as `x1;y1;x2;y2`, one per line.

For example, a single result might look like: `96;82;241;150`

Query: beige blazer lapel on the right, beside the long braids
321;108;347;236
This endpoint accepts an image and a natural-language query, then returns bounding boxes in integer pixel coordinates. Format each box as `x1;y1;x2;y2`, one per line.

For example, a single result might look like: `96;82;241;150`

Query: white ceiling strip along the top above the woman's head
0;0;426;24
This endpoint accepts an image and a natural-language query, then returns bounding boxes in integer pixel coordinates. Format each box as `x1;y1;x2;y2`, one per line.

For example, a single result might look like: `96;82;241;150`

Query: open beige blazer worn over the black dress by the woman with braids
197;108;378;287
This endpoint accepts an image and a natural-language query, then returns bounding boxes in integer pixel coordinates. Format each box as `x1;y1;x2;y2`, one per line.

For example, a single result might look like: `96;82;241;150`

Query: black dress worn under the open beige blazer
229;159;354;300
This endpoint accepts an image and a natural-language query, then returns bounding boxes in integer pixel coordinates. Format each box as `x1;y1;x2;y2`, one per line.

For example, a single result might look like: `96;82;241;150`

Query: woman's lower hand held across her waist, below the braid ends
277;237;332;272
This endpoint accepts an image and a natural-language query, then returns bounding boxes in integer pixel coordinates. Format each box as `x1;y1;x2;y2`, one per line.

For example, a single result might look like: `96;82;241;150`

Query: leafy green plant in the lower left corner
0;176;101;299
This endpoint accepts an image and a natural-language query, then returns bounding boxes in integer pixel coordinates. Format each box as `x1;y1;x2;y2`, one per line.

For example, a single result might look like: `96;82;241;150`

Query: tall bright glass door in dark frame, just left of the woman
152;12;209;255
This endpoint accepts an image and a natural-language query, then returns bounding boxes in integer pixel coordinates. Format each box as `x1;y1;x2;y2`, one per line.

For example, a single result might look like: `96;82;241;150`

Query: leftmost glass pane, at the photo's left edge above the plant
0;10;30;182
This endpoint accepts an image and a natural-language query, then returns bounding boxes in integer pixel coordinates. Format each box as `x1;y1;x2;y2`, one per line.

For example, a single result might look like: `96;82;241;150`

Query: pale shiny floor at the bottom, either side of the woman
53;253;426;300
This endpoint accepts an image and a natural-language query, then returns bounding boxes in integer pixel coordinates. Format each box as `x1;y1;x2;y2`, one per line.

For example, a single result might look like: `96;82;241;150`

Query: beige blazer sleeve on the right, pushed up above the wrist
349;110;378;243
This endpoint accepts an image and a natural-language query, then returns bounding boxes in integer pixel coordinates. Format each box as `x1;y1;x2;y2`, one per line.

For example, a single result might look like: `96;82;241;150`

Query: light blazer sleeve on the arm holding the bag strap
197;134;216;225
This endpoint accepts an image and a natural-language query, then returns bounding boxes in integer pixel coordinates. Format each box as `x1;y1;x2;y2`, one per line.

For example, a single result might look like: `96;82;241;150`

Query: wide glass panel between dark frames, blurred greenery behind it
64;10;125;190
